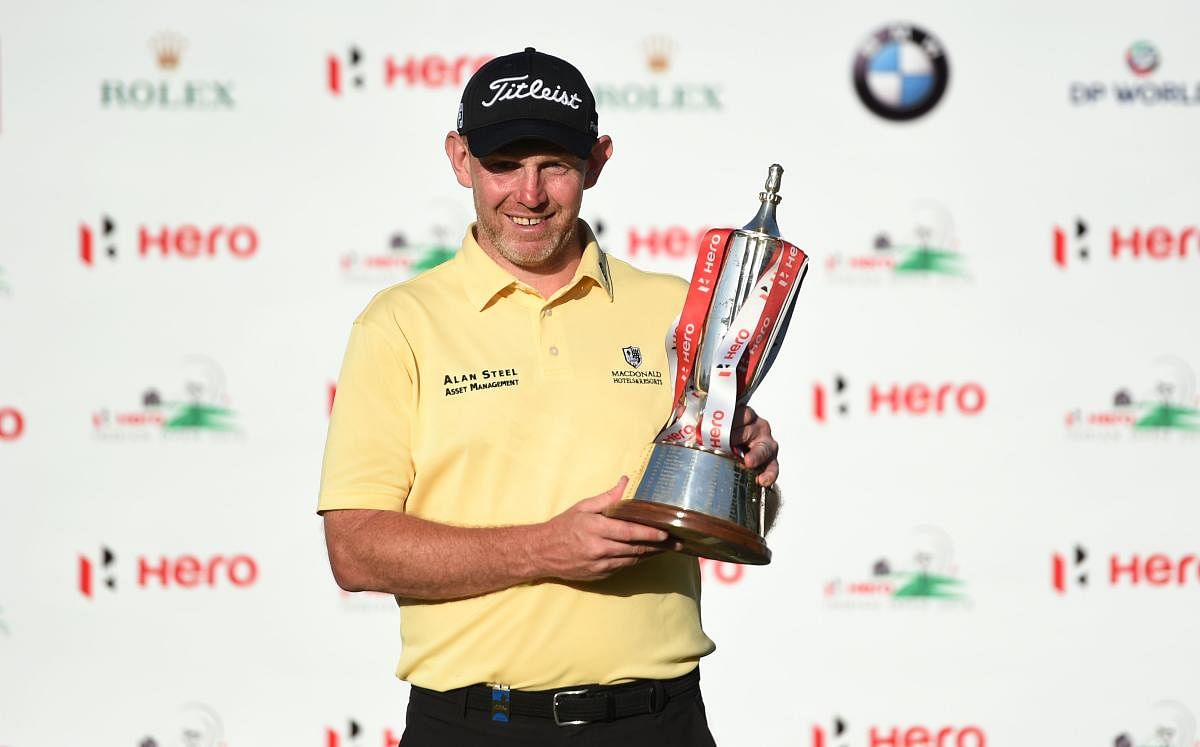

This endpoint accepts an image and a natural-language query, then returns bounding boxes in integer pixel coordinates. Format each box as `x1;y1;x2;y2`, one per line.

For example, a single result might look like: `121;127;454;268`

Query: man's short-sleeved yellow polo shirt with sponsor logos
318;223;714;691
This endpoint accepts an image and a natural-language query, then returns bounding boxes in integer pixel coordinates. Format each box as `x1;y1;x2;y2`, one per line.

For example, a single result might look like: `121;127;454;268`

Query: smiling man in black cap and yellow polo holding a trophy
319;48;778;747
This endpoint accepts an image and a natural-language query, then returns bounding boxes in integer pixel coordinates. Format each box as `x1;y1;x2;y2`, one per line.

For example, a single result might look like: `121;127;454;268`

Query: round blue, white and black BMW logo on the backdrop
854;23;950;121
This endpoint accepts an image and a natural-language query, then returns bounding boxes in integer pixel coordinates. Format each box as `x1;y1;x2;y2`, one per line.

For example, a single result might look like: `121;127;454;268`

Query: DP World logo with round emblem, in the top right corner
1068;40;1200;108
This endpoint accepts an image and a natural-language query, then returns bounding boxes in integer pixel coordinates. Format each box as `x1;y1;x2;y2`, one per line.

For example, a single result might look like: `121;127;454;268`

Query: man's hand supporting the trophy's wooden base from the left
530;477;678;581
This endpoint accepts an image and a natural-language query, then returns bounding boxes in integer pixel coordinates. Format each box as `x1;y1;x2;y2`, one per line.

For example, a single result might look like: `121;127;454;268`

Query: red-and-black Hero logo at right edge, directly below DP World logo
1052;217;1200;268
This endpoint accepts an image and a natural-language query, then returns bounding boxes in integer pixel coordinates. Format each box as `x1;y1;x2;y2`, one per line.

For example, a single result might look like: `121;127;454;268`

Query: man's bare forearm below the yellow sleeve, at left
325;509;541;599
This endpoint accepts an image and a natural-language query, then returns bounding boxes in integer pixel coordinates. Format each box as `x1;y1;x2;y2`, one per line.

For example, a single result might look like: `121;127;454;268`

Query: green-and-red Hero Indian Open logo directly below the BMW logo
823;202;970;283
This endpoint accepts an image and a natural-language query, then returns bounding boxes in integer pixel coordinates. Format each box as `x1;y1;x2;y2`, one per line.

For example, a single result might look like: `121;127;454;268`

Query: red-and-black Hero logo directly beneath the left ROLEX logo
79;215;258;267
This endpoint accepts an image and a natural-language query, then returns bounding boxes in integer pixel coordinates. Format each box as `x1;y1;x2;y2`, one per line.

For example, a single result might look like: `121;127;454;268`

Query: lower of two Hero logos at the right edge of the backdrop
1050;544;1200;596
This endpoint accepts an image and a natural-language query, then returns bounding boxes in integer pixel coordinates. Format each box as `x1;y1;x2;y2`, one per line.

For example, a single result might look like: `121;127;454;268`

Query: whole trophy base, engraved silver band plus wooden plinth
605;442;778;566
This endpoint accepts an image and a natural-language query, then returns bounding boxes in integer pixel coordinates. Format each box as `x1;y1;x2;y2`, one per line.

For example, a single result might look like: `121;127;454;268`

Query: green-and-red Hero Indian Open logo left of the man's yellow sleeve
91;355;239;441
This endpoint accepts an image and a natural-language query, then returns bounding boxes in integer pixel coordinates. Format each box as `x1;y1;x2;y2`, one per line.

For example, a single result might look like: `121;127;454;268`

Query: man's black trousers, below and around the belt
400;672;716;747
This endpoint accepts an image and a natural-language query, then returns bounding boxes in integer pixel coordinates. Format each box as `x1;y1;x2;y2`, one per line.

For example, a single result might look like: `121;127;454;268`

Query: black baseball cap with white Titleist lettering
458;47;599;159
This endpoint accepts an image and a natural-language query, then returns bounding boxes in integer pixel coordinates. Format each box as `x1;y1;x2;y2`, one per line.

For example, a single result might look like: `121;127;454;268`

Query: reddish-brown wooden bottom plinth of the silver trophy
605;501;770;566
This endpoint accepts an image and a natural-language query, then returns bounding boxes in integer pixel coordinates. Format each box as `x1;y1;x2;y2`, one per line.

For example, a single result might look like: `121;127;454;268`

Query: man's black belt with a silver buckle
426;668;700;727
